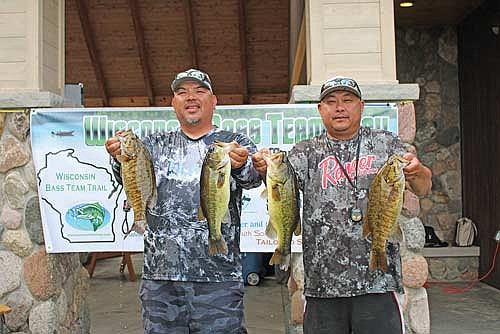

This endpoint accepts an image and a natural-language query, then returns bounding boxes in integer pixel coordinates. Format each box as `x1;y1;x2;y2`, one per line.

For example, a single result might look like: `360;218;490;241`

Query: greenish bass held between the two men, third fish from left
264;152;301;270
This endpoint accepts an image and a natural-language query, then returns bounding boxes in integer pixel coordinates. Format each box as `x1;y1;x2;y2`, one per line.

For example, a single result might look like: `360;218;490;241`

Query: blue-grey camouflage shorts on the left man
139;280;247;334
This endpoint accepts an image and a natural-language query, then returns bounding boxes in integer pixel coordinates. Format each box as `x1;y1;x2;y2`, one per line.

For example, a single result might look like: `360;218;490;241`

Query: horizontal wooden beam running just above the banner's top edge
84;93;289;107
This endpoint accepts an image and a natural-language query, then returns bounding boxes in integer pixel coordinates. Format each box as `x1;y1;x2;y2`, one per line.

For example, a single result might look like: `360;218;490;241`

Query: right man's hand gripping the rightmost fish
403;152;432;195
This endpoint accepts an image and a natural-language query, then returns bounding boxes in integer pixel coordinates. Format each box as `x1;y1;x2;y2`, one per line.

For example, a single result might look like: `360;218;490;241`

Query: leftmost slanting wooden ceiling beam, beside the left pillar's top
76;0;108;106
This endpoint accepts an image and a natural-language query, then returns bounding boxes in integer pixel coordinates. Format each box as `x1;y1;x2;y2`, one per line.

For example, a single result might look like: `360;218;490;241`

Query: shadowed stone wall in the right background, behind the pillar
396;27;462;243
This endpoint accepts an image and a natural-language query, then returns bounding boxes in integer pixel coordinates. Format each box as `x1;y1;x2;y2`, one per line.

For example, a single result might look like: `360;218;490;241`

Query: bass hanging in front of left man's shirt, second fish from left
198;141;237;255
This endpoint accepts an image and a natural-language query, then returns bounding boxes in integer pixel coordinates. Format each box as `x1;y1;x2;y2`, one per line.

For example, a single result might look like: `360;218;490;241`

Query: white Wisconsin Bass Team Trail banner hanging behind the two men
31;103;398;253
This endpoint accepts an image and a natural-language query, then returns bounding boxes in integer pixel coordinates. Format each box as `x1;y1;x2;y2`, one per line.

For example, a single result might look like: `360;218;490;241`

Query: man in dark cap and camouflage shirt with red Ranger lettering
253;76;432;334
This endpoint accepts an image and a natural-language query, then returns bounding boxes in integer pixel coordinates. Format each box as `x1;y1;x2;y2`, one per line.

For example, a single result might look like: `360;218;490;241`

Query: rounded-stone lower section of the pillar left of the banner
0;110;90;334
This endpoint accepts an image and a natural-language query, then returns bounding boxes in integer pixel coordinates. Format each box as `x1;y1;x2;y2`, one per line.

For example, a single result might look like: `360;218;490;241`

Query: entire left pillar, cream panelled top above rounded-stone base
0;0;90;334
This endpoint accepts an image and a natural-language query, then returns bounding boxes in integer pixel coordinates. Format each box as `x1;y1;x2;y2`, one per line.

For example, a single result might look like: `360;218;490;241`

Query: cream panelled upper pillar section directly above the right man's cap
306;0;397;85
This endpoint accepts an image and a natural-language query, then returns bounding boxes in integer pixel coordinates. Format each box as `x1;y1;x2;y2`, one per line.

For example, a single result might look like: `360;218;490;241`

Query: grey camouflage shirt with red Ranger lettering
289;127;405;298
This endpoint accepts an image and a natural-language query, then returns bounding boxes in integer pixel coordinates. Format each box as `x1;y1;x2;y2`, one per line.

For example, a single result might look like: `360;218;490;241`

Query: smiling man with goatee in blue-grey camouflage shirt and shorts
106;69;261;334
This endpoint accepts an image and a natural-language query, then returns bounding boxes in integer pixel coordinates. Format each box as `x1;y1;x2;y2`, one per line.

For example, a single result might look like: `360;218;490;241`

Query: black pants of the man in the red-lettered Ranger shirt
304;292;404;334
